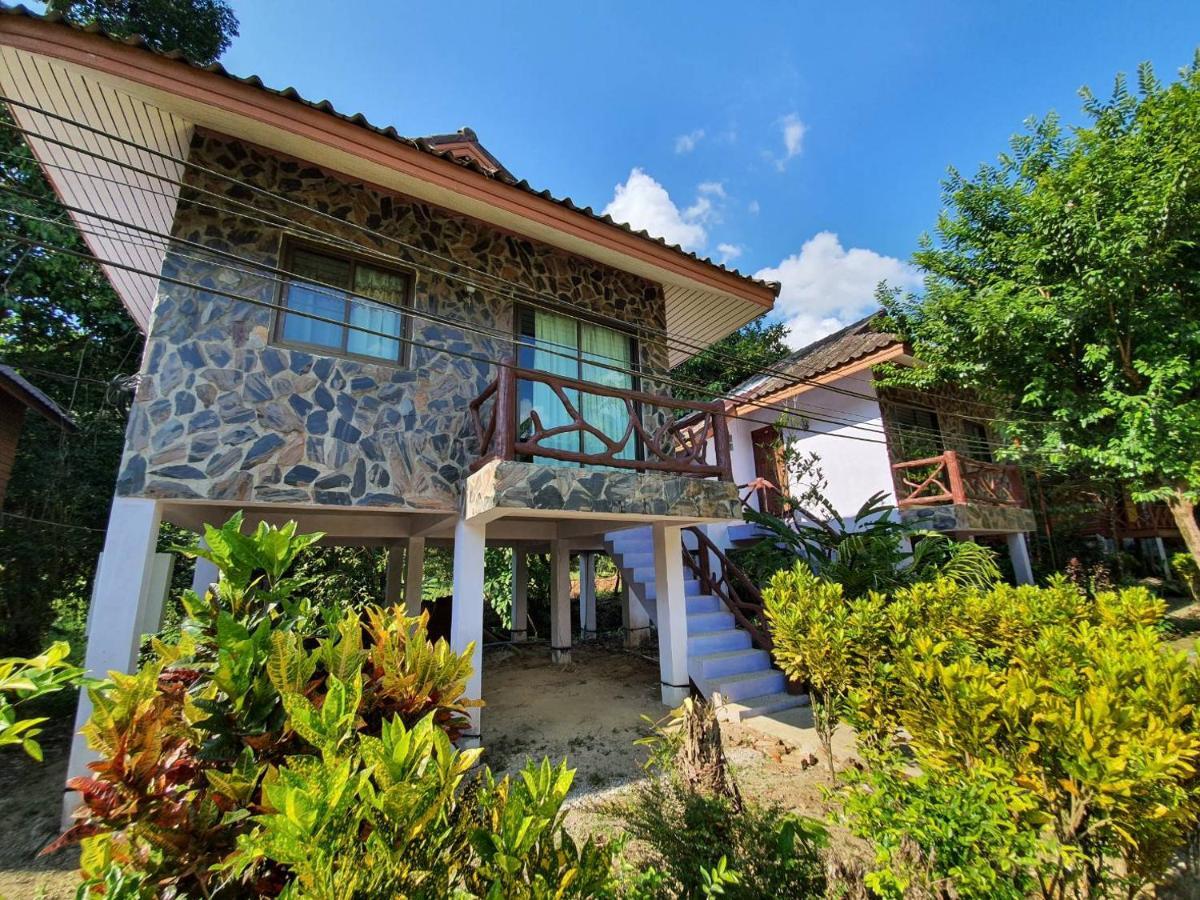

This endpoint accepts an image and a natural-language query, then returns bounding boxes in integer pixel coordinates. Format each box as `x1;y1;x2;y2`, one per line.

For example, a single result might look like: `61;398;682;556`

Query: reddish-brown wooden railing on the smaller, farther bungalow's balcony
892;450;1026;509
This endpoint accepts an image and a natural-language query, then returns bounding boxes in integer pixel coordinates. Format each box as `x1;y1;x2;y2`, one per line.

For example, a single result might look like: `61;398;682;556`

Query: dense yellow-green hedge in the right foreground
767;566;1200;896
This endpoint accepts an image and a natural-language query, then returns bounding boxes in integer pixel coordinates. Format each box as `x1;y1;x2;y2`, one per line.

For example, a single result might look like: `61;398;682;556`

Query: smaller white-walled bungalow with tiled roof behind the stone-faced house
730;316;1034;583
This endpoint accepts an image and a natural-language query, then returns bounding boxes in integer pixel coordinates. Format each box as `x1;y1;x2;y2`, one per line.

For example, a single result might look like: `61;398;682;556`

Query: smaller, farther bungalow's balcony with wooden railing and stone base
892;450;1033;533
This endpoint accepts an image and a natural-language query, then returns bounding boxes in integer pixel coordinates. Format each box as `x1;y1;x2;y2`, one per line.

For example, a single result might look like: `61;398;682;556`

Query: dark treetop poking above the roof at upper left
46;0;238;66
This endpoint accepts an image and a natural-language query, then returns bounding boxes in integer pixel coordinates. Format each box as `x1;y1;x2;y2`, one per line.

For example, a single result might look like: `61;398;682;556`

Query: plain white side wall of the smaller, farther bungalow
730;372;895;517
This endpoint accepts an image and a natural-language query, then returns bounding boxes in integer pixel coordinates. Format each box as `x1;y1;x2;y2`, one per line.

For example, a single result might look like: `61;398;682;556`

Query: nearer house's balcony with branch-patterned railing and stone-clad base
466;362;740;522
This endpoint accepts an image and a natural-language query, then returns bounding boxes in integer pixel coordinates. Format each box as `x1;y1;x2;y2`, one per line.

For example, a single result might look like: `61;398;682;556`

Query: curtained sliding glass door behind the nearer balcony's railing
517;307;637;466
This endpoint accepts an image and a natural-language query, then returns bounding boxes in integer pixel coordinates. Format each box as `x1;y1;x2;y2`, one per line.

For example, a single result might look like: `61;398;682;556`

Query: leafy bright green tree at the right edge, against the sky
883;56;1200;559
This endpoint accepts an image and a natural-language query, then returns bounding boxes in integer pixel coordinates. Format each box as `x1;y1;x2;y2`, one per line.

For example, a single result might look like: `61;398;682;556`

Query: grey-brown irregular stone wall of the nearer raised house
118;130;667;510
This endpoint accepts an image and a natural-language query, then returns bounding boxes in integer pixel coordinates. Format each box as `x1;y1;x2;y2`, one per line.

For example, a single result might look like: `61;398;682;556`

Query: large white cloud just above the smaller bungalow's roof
755;232;920;348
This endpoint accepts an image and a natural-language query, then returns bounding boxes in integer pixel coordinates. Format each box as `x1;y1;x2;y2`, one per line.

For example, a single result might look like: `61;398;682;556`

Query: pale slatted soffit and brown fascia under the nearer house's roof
0;47;766;355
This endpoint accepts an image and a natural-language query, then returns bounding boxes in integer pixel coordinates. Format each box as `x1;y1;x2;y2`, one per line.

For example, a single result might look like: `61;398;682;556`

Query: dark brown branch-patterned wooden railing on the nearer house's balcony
469;361;733;481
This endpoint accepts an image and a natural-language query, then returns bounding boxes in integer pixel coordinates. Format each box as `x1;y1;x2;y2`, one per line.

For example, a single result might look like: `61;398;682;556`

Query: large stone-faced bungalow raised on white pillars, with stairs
0;1;816;801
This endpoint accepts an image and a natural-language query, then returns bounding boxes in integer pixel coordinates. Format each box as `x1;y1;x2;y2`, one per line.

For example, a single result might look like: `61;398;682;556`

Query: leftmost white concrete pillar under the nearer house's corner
62;497;162;823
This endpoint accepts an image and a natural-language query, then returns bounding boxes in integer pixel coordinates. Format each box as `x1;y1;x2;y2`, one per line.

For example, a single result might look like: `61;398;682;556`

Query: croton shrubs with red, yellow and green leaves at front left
60;516;613;900
